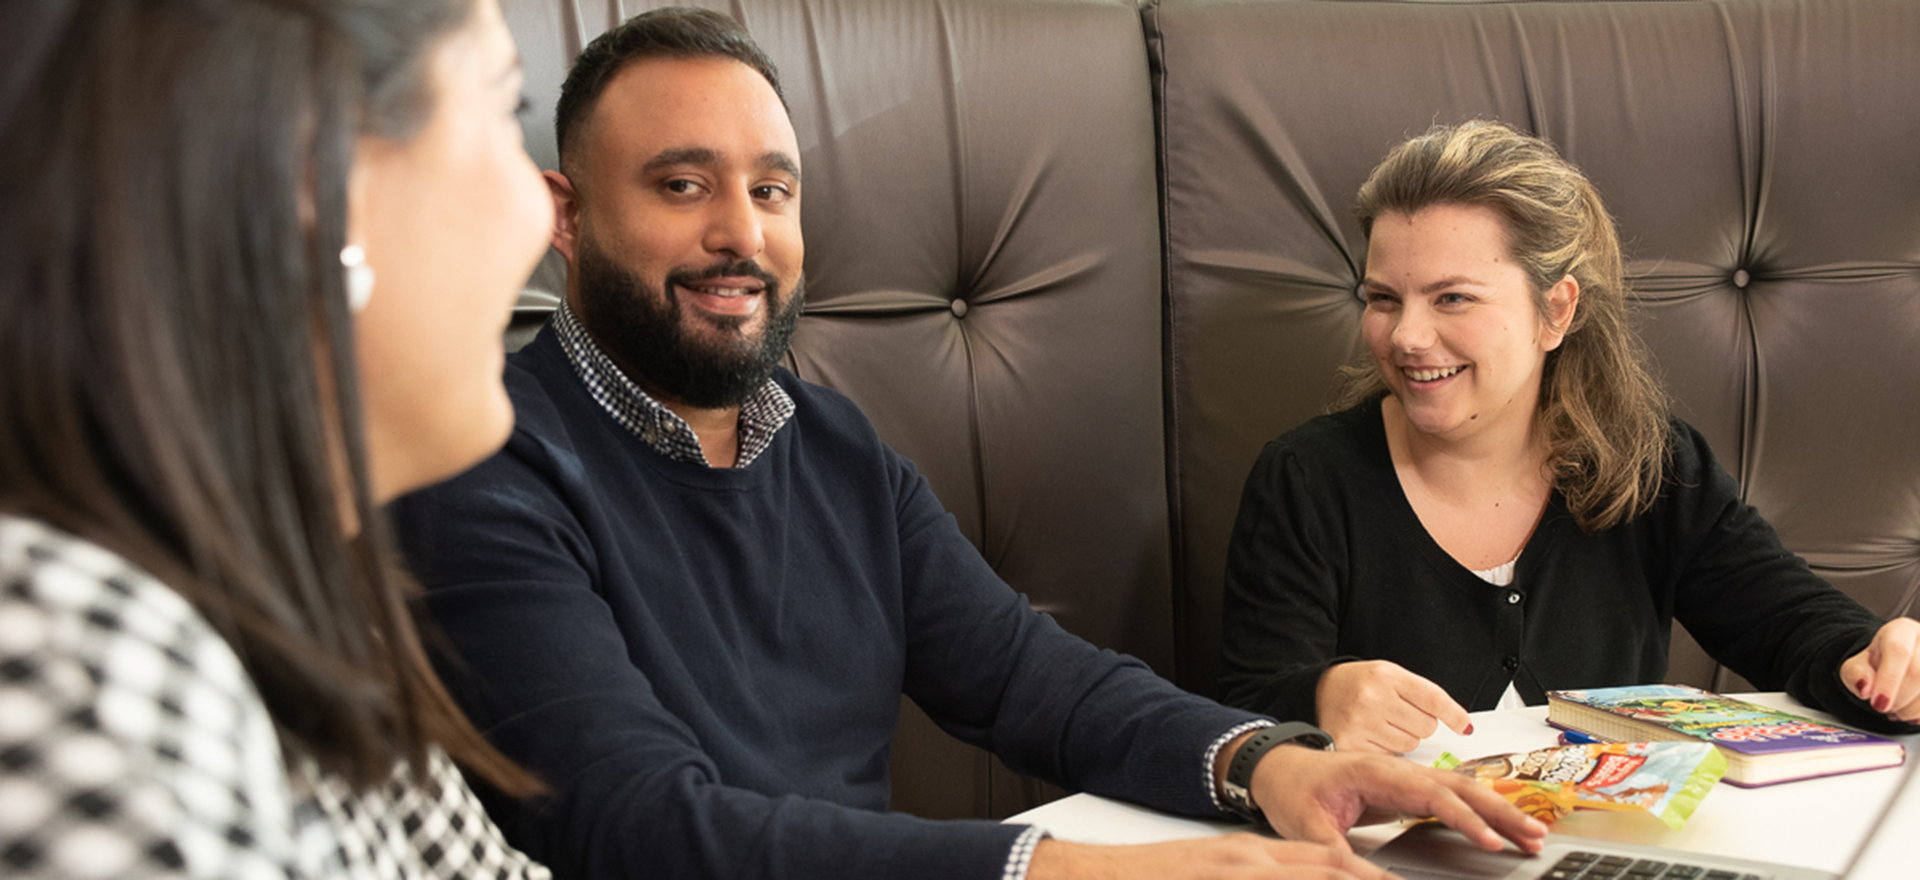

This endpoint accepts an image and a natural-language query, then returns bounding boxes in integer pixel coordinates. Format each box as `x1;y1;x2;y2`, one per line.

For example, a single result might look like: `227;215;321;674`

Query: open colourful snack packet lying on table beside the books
1434;742;1726;828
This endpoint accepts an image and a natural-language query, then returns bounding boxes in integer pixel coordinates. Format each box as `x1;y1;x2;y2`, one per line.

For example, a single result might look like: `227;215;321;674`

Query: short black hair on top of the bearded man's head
553;6;787;176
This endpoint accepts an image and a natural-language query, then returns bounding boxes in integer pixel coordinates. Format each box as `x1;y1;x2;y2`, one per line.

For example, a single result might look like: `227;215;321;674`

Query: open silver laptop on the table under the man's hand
1367;757;1920;880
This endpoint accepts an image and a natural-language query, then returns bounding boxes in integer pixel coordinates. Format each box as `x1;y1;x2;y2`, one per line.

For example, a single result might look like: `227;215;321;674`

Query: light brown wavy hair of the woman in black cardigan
1332;121;1668;534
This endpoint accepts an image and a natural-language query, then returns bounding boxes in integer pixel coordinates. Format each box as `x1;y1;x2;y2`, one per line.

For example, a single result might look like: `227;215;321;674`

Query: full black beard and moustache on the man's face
572;236;806;409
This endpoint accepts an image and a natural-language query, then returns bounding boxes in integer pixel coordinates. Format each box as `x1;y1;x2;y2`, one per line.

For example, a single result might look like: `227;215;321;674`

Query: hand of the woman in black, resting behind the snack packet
1313;661;1473;753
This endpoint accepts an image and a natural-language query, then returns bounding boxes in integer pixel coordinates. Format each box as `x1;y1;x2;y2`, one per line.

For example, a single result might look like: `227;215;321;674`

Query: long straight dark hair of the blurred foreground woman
0;0;538;794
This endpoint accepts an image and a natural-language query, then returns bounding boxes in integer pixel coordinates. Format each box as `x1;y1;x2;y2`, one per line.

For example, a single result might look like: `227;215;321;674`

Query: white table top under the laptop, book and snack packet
1008;694;1920;872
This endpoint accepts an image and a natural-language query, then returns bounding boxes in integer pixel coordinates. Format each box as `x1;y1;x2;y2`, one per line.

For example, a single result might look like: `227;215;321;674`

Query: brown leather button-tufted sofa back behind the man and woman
503;0;1920;817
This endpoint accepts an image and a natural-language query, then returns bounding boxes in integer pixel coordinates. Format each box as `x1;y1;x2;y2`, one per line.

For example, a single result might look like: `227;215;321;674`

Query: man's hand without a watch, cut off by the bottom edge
1027;834;1388;880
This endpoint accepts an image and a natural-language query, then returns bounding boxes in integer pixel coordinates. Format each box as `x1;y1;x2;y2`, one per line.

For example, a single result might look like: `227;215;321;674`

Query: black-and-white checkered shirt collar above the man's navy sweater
547;302;793;467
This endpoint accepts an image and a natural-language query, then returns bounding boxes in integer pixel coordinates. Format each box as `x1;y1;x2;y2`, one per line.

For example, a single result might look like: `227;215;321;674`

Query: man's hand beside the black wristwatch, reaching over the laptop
1254;746;1548;853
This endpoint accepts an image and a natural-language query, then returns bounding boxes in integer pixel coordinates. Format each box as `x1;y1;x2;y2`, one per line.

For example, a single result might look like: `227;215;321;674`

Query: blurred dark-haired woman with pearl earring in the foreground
0;0;551;878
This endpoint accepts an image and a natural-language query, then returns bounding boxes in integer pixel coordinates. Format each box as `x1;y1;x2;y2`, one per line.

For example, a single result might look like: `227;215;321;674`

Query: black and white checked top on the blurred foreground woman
0;515;549;880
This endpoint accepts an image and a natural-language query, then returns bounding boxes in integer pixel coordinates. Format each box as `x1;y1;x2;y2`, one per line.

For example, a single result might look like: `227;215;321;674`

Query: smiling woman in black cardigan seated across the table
1221;121;1920;751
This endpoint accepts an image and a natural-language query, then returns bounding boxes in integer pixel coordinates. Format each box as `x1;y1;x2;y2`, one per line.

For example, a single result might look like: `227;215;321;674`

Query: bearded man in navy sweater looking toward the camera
397;10;1546;880
